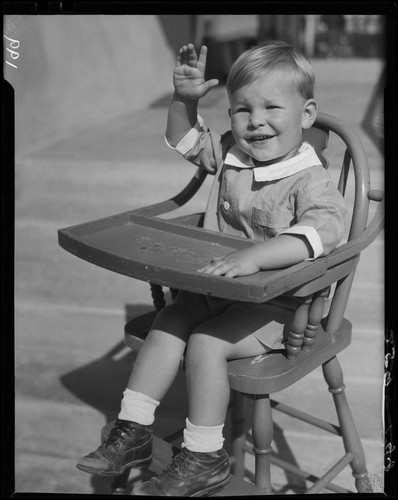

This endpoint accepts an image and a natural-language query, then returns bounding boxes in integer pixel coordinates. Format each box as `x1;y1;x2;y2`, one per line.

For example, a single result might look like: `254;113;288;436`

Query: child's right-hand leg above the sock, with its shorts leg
186;304;292;426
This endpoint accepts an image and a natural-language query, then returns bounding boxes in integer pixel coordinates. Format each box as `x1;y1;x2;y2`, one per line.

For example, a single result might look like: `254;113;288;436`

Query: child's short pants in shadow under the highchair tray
152;291;294;350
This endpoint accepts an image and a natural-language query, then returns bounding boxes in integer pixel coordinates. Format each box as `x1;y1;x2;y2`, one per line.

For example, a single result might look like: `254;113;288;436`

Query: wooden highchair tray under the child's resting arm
58;211;327;302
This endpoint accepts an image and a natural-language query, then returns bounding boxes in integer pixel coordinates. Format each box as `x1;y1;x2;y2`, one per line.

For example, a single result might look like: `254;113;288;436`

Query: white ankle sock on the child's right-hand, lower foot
182;419;224;453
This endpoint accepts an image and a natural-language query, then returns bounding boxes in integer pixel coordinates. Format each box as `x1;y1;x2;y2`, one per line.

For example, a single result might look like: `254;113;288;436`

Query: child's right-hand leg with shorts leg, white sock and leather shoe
133;307;282;496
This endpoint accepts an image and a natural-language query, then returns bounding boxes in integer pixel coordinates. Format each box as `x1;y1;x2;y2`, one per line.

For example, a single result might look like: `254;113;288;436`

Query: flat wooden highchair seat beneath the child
125;311;352;394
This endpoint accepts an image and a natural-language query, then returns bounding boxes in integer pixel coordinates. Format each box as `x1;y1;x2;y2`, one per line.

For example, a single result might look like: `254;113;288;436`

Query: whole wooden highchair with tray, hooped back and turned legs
59;113;384;494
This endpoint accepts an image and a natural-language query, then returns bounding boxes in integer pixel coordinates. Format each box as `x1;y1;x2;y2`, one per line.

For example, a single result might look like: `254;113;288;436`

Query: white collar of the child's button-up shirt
225;142;322;182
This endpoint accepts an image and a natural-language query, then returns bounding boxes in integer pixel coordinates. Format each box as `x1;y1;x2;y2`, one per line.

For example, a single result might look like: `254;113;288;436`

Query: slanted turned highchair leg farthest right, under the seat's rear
322;357;372;493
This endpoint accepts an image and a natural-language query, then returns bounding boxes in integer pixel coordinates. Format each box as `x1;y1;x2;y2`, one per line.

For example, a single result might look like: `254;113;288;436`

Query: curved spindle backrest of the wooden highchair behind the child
274;114;383;359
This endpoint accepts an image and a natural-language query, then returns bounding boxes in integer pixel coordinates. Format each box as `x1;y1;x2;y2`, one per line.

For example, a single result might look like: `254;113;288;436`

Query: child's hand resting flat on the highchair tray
198;249;260;278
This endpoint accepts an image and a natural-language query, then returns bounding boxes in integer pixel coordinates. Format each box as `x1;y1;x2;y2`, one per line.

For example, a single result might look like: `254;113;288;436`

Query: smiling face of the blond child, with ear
229;69;316;165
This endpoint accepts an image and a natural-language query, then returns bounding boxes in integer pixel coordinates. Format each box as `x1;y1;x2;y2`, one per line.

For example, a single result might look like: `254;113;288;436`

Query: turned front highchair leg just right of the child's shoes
252;394;273;495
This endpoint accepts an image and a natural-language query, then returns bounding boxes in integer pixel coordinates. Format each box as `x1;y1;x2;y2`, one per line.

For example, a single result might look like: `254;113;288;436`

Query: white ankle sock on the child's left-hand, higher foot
118;389;159;425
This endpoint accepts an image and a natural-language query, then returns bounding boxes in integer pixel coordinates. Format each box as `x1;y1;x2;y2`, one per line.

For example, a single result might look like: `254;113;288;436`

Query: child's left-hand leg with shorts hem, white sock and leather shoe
76;304;210;476
